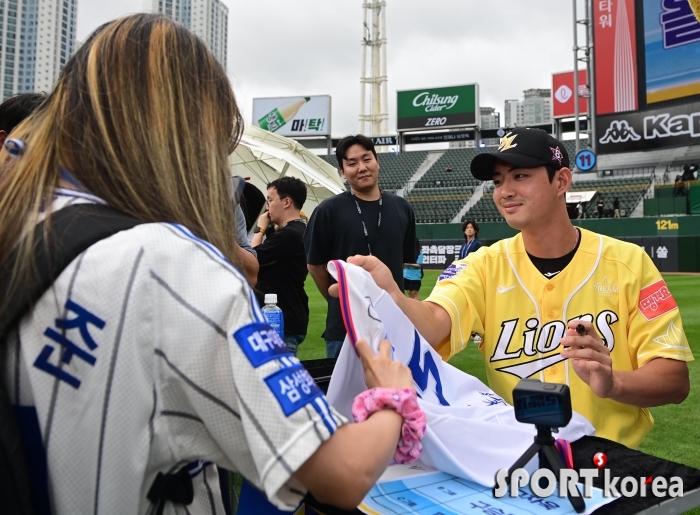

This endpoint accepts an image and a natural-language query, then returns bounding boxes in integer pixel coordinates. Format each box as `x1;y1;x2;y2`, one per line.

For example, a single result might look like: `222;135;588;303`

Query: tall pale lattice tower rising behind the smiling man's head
360;0;389;136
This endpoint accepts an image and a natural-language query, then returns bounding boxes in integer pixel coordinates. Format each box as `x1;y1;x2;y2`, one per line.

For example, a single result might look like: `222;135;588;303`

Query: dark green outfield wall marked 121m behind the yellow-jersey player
417;215;700;272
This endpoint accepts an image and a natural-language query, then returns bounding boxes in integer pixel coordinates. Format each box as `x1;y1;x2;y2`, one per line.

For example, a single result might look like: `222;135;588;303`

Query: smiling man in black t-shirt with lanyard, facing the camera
304;134;416;358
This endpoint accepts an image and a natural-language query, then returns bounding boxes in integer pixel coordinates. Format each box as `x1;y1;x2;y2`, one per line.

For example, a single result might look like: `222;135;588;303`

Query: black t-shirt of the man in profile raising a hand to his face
255;220;309;335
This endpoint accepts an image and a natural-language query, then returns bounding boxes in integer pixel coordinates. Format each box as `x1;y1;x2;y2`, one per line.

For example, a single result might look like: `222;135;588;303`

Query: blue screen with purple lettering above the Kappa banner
641;0;700;104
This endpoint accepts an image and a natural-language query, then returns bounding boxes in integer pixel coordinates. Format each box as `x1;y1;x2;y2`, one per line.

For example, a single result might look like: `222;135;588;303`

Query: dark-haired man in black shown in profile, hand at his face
251;177;309;356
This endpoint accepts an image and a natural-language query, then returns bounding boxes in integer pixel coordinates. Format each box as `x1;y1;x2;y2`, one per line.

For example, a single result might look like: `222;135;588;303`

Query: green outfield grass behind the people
299;270;700;476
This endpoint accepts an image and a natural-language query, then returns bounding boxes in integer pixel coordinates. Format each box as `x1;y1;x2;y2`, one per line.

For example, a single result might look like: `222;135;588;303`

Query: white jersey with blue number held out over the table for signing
327;260;595;486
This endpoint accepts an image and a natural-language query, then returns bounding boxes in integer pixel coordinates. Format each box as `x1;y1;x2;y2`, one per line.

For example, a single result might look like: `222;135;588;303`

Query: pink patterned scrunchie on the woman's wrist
352;388;425;465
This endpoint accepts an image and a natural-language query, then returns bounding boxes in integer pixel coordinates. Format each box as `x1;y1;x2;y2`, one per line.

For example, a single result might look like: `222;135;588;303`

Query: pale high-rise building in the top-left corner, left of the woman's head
0;0;78;100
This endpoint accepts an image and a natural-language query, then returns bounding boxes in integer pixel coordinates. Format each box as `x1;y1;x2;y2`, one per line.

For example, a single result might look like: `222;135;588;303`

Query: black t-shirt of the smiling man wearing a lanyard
304;191;416;340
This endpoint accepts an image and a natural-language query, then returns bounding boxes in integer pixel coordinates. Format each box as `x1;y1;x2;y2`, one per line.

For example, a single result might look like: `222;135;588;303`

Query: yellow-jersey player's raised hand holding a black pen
561;320;615;399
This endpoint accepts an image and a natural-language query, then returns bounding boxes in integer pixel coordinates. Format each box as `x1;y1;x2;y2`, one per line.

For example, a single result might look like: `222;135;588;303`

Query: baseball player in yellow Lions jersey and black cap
342;128;693;447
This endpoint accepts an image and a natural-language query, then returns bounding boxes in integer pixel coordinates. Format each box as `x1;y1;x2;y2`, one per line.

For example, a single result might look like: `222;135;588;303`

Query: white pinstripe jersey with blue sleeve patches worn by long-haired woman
0;190;344;515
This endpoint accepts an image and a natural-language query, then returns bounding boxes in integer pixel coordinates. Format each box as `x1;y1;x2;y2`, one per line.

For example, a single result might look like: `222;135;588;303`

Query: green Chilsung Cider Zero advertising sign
396;84;479;131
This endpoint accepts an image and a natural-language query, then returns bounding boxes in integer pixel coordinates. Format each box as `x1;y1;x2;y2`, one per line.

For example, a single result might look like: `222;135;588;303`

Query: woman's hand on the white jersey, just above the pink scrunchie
355;340;414;388
